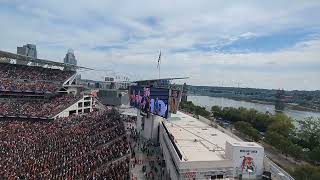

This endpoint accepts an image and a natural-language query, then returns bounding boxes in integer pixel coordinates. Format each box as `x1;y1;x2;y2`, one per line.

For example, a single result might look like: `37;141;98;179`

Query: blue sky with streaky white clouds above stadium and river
0;0;320;90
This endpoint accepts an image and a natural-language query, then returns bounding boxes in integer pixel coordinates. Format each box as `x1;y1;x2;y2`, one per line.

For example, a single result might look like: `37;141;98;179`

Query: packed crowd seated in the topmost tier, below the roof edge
0;63;75;92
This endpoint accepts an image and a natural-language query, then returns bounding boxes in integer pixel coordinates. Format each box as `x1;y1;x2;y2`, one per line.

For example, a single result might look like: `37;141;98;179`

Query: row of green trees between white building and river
211;106;320;164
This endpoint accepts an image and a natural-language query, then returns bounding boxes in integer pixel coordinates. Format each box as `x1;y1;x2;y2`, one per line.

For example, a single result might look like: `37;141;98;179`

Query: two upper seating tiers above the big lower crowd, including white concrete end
0;51;93;119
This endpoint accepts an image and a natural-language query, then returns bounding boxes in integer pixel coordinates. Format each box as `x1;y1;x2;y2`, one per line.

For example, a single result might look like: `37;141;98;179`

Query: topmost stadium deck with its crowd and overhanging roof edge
0;51;83;94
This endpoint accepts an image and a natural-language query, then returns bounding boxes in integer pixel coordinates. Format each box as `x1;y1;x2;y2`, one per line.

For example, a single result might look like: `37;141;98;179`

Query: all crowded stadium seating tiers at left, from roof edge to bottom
0;51;130;179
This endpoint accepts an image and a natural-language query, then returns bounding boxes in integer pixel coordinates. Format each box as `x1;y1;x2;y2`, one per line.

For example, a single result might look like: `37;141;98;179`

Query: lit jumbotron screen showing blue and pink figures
130;86;169;118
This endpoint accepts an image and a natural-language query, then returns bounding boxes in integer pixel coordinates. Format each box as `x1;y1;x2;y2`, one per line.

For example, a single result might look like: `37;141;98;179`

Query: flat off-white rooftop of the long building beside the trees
164;111;256;161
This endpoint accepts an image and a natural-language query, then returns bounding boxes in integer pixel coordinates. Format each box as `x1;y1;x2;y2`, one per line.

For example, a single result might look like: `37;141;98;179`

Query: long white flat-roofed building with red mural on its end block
158;112;264;180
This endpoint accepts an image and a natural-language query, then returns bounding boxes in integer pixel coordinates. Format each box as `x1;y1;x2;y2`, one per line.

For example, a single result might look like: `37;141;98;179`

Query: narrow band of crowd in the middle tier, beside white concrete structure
0;94;79;118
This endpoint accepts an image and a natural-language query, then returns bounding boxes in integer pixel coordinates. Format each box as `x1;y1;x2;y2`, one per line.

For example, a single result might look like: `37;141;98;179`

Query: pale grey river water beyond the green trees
188;96;320;120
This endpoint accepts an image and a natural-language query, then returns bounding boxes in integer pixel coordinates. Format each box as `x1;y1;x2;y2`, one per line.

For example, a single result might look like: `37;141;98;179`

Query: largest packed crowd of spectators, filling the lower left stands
0;110;130;180
